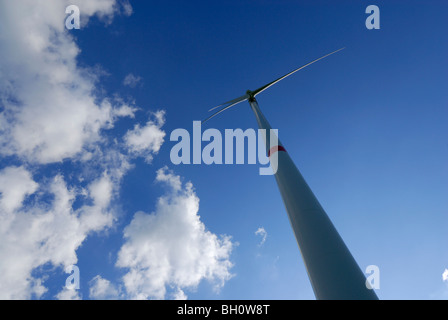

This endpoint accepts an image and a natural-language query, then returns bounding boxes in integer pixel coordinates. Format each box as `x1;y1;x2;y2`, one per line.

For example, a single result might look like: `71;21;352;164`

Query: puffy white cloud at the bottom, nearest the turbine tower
117;168;234;299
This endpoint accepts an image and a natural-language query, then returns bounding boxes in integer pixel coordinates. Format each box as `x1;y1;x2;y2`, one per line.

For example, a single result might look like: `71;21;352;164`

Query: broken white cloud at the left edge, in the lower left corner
0;167;124;299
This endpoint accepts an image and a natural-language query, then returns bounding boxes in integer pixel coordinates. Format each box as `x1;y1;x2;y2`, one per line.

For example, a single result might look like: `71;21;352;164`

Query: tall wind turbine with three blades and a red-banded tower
202;48;378;300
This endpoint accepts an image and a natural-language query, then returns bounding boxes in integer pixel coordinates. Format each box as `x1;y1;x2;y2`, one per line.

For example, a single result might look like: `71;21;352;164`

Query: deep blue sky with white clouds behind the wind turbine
0;0;448;299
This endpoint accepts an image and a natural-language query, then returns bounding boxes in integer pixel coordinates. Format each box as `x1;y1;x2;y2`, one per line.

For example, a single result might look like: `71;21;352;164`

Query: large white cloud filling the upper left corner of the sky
0;0;136;163
